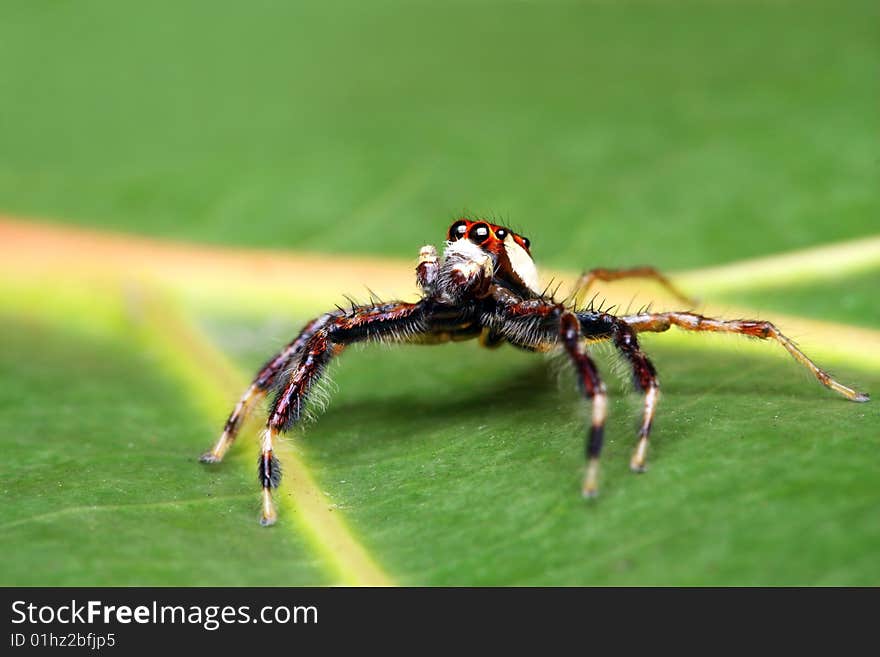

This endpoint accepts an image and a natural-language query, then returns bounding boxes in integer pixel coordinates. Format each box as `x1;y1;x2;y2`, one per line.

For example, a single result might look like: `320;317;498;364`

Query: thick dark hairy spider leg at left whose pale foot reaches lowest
258;302;425;525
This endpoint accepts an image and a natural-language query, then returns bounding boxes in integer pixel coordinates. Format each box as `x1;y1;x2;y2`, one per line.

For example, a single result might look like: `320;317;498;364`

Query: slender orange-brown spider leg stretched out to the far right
621;312;870;402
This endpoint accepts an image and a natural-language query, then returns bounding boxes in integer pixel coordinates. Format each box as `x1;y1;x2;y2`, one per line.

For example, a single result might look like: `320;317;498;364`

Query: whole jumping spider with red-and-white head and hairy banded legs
201;218;869;525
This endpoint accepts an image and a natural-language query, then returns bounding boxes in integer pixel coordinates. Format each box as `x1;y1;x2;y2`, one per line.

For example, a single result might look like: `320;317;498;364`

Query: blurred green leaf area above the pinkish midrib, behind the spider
0;0;880;268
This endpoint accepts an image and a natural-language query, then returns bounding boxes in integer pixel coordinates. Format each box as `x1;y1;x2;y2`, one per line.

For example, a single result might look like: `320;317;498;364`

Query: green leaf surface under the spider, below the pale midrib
0;296;880;585
